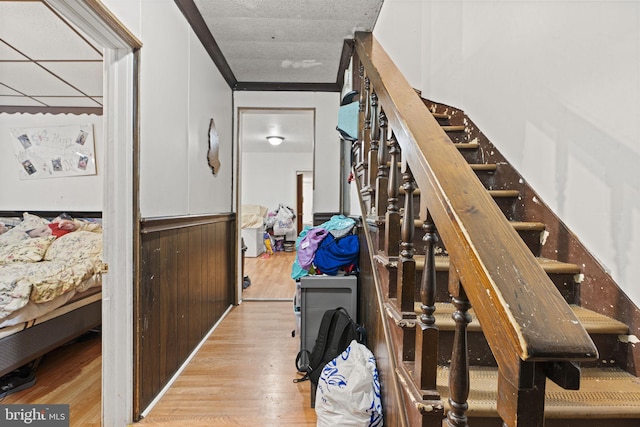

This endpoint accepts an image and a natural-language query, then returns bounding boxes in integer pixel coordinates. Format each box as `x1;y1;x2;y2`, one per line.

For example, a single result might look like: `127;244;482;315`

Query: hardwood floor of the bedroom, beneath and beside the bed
0;333;102;427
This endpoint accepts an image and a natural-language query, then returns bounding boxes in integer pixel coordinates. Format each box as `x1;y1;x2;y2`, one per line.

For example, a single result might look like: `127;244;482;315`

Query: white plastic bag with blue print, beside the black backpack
315;340;383;427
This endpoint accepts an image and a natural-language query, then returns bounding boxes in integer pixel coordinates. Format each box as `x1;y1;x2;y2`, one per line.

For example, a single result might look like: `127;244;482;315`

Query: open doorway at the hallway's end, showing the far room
238;108;315;300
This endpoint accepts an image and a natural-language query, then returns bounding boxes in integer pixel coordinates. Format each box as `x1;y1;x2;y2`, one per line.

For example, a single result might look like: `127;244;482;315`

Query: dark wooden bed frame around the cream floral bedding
0;211;102;376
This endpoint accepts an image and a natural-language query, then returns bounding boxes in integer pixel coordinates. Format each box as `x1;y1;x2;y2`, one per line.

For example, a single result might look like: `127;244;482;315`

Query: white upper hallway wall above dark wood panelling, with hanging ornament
114;0;233;217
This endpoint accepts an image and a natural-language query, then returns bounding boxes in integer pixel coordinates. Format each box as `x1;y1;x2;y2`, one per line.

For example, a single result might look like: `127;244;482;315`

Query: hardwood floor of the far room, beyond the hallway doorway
242;252;296;300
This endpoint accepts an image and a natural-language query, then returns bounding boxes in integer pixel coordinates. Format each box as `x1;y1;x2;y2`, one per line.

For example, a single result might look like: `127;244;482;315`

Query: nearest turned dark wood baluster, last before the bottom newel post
447;278;471;427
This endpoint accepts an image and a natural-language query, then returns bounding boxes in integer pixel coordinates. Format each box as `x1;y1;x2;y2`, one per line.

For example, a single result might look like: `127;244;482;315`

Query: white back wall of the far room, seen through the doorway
241;153;313;215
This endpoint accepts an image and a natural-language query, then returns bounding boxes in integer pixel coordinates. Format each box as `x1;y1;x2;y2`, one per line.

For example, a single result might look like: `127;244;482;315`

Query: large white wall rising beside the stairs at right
374;0;640;304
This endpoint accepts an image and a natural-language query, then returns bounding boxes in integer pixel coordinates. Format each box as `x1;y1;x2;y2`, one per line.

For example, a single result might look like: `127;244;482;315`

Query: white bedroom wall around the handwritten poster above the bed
0;113;104;211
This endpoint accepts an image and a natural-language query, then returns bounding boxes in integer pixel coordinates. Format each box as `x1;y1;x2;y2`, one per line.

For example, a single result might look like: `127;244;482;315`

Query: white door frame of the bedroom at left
44;0;142;426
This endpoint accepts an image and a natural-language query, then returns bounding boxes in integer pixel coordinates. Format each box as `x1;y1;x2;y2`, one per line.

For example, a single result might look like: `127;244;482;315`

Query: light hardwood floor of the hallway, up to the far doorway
135;301;316;427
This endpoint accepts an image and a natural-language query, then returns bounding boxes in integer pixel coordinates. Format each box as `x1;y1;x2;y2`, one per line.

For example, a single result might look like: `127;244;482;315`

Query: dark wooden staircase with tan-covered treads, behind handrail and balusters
354;100;640;427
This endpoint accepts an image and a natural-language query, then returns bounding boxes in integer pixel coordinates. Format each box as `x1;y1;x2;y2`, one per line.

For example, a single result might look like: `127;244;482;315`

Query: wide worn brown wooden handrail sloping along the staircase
355;27;597;379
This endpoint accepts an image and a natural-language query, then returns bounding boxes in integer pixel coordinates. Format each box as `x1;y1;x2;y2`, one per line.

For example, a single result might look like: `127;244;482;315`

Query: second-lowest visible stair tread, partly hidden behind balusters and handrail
414;302;629;335
